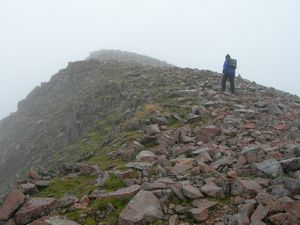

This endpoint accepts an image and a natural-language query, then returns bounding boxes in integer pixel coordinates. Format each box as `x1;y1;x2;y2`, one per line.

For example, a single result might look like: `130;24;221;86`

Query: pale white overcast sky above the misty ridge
0;0;300;118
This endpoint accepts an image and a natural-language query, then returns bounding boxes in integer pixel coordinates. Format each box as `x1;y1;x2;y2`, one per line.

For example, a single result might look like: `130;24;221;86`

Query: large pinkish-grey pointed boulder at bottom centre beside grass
118;191;164;225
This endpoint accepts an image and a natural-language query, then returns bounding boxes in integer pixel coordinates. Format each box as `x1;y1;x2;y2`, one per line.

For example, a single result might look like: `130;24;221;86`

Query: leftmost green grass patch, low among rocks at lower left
35;176;96;198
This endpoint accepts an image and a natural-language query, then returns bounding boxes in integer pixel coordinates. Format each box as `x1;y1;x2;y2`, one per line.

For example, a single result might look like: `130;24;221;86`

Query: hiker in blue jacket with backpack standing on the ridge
222;54;237;94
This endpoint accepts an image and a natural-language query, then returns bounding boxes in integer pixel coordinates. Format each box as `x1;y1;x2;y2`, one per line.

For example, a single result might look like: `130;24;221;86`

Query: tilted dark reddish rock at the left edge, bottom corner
0;190;25;220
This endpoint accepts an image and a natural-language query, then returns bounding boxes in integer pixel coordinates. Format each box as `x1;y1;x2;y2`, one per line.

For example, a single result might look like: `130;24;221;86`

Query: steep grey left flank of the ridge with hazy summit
0;51;172;196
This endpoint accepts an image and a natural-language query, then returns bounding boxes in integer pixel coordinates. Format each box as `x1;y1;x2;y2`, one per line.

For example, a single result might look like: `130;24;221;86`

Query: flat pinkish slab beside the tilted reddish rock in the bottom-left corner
15;198;60;225
